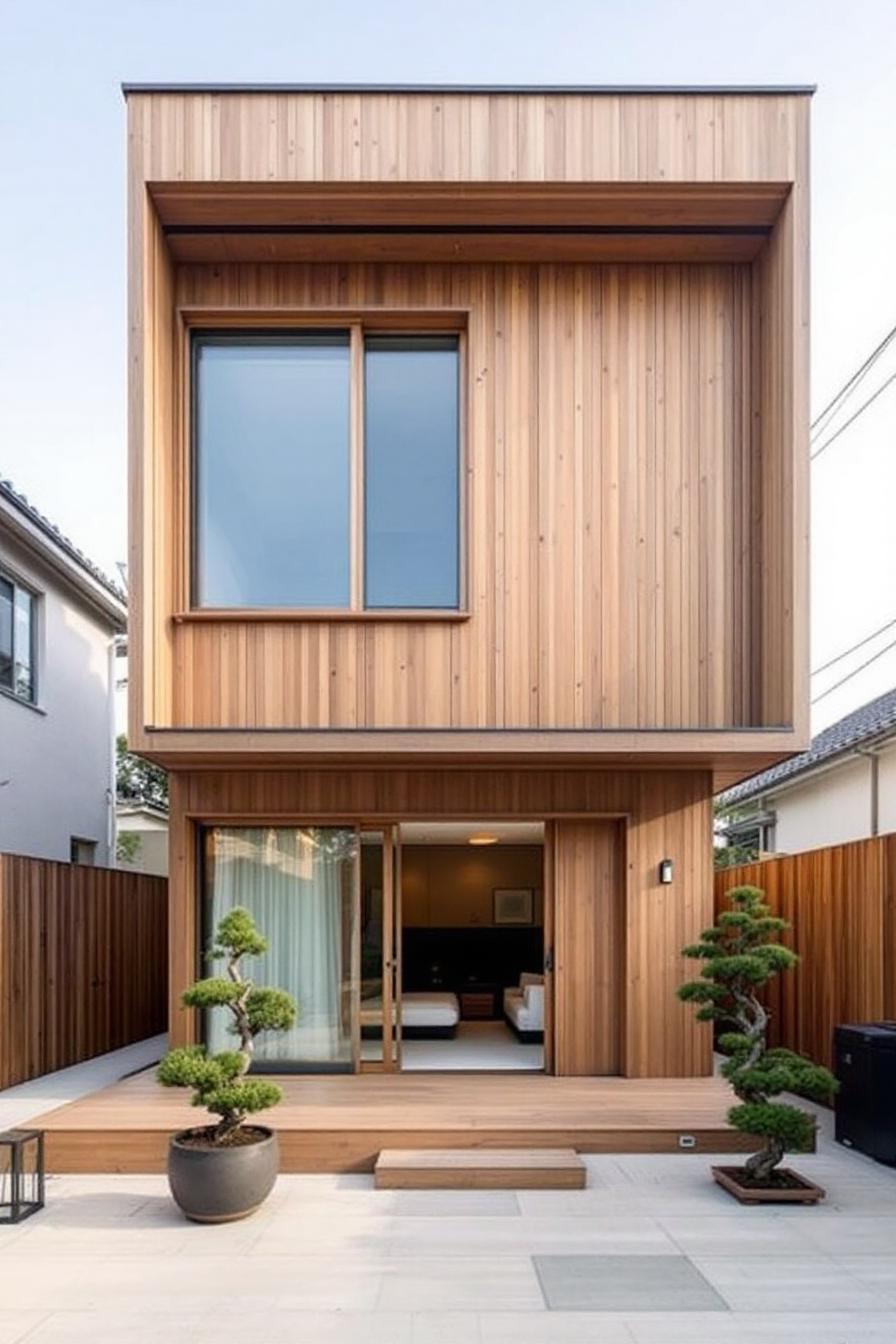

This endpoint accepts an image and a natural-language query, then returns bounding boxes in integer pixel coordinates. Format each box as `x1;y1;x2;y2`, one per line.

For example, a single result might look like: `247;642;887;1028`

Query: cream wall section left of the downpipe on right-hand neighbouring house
768;758;870;853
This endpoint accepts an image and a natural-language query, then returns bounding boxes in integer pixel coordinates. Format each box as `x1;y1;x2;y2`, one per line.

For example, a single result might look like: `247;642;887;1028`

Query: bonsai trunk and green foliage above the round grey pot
156;906;298;1144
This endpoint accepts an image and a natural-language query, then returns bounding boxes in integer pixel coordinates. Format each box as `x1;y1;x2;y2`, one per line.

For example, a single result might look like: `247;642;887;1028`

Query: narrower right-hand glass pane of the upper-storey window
364;336;458;607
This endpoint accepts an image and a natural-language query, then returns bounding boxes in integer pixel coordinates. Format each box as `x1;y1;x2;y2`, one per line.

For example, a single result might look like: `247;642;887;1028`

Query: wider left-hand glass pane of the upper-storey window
193;332;349;607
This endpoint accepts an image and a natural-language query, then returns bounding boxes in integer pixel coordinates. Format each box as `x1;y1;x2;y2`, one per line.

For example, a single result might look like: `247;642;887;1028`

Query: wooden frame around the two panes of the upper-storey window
192;325;469;621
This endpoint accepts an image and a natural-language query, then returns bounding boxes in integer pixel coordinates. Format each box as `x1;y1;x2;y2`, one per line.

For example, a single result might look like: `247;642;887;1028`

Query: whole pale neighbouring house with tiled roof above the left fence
0;481;126;864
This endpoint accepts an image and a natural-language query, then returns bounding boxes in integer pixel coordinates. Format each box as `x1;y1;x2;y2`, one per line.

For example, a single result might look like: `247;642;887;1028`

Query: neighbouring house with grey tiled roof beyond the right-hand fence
719;689;896;853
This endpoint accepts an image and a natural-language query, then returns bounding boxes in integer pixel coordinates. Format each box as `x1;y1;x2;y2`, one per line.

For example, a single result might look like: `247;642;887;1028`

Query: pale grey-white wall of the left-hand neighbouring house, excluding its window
0;538;114;864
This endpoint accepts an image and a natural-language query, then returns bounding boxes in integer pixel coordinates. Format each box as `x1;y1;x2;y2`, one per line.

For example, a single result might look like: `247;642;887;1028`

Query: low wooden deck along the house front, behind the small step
30;1070;751;1172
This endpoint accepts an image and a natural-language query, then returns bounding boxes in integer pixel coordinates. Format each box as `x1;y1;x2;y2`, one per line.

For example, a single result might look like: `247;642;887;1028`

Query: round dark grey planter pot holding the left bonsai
168;1125;279;1223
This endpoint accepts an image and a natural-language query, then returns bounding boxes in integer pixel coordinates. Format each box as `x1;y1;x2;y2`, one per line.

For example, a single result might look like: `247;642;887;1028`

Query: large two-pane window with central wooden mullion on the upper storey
193;329;461;610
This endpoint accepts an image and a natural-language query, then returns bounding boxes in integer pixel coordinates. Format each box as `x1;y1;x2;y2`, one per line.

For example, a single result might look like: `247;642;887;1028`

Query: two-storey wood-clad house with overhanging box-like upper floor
126;86;810;1078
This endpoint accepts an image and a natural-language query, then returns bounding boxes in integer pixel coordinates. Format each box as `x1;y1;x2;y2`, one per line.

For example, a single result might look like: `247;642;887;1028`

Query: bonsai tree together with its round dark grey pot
157;906;297;1223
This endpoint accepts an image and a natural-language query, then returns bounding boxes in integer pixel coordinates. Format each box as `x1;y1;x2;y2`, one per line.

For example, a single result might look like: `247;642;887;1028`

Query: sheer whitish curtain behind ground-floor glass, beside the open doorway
206;827;359;1066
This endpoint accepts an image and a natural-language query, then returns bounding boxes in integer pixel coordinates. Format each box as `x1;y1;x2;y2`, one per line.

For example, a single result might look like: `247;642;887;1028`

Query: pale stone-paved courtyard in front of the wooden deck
0;1102;896;1344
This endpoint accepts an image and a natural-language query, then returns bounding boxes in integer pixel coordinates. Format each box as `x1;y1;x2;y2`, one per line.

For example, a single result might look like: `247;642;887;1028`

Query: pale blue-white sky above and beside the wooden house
0;0;896;730
